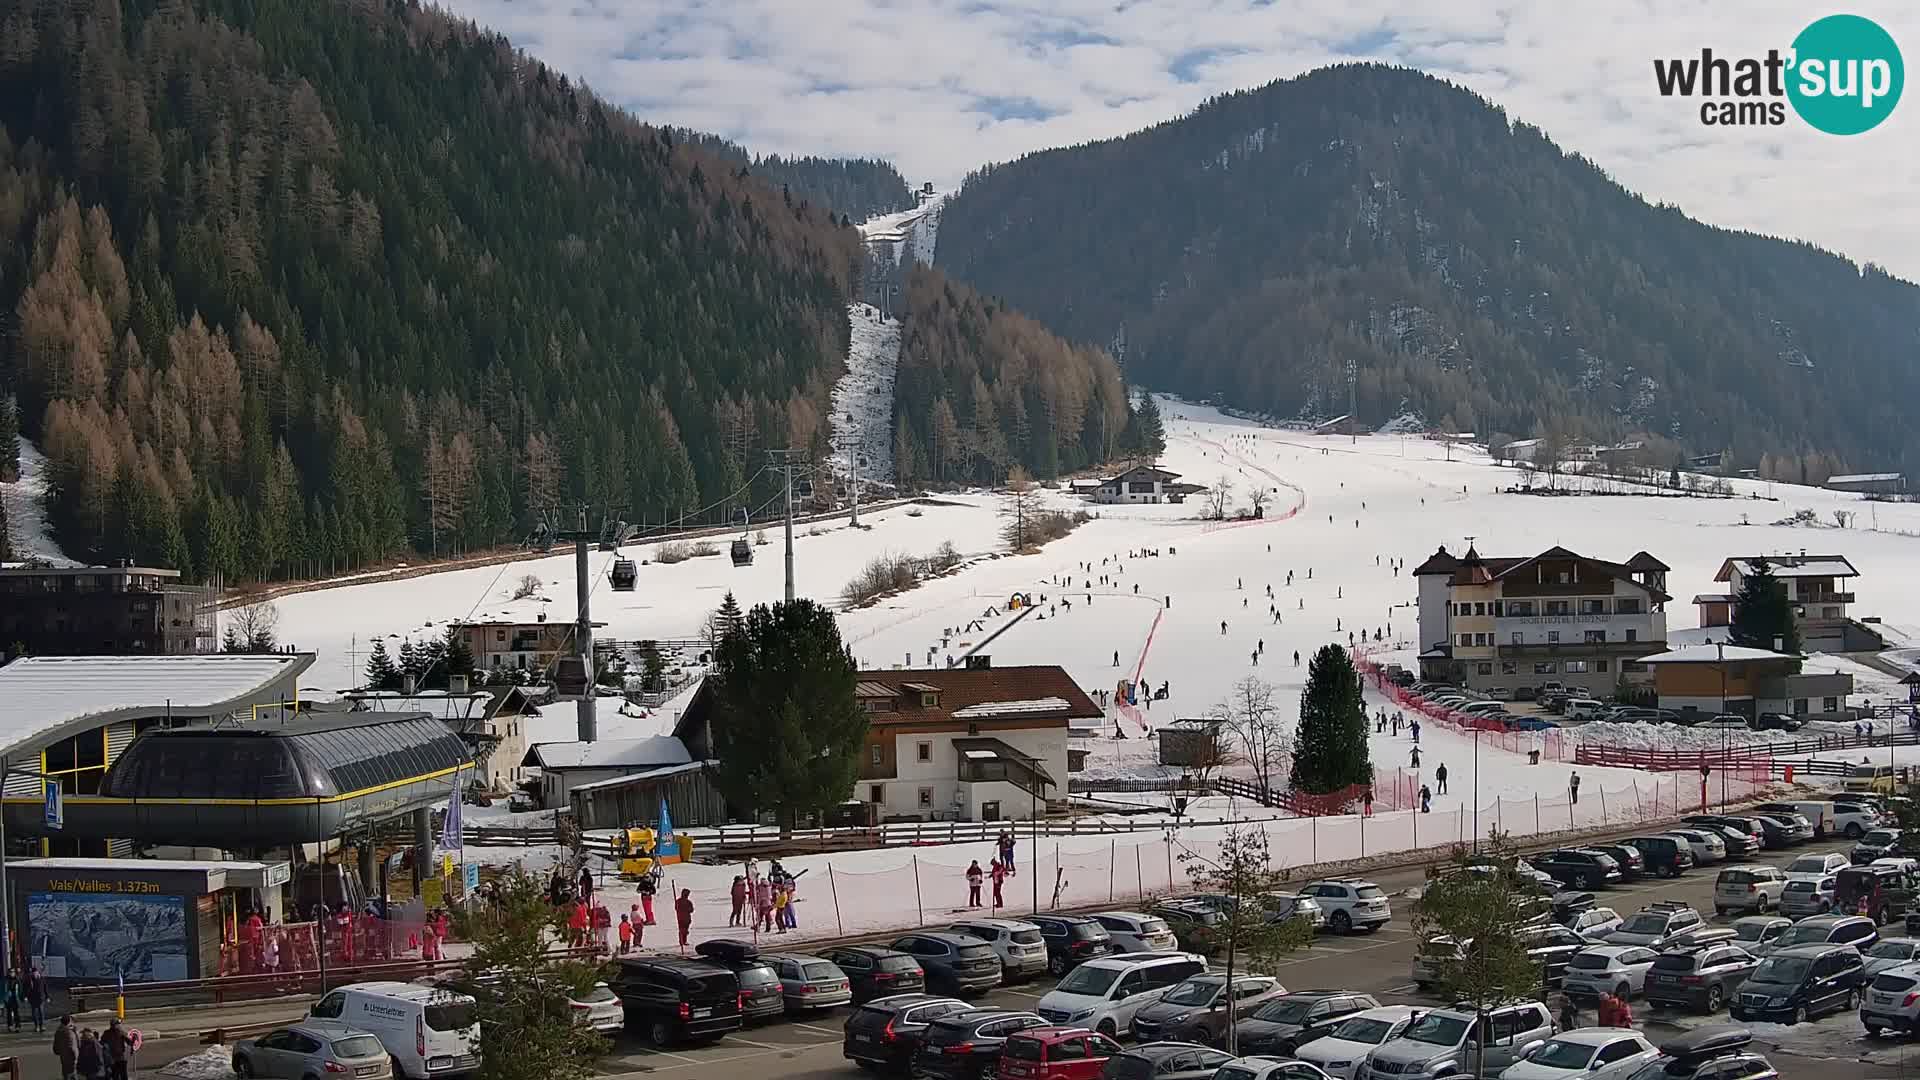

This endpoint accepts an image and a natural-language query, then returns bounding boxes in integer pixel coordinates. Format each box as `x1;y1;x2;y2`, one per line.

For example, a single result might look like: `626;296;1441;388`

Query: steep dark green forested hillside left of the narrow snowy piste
0;0;860;580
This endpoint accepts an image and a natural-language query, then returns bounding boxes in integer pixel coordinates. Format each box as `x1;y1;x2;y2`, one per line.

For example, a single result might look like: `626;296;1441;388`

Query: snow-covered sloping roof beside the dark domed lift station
0;653;313;753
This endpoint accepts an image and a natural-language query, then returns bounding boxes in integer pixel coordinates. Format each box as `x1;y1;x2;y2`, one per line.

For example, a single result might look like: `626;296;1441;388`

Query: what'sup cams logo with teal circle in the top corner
1653;15;1907;135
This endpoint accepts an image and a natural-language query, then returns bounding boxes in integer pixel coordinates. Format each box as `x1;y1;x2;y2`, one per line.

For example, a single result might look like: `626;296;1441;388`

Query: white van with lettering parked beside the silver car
307;982;480;1080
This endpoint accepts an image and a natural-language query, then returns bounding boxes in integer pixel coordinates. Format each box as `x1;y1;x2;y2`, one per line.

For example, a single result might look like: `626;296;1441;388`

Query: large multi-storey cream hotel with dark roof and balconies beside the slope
1413;546;1672;698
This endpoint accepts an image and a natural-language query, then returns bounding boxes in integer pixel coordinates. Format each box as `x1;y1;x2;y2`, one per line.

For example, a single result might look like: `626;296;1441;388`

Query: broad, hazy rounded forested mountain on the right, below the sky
937;65;1920;469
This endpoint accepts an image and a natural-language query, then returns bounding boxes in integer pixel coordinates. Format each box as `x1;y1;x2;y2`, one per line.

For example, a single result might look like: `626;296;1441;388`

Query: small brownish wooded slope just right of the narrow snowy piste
893;263;1162;484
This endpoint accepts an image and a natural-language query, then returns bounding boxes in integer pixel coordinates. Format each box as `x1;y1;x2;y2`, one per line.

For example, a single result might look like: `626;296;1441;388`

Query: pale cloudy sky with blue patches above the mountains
442;0;1920;281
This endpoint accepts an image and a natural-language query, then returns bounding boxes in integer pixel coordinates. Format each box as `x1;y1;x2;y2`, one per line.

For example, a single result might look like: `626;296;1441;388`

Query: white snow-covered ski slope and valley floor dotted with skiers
278;398;1920;936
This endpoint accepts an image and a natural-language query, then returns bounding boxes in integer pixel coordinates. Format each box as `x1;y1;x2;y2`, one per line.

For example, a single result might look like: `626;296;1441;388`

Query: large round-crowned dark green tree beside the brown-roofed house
712;598;866;824
